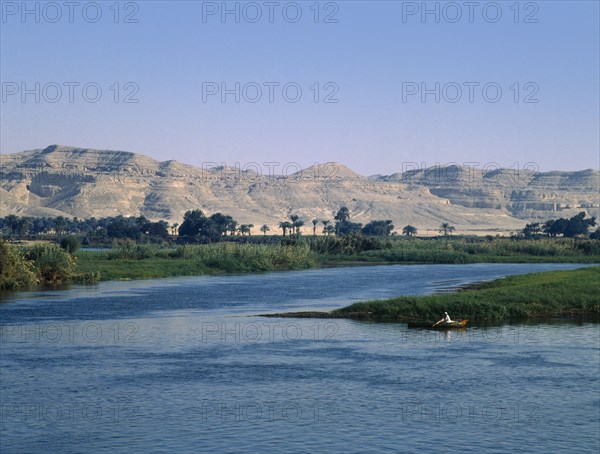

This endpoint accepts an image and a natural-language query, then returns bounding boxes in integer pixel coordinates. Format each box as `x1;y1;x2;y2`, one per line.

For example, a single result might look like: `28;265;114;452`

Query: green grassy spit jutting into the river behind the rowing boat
333;266;600;323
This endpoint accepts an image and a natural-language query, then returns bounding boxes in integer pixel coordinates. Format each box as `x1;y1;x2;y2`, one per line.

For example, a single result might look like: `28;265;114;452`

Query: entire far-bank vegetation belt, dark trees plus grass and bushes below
0;206;600;289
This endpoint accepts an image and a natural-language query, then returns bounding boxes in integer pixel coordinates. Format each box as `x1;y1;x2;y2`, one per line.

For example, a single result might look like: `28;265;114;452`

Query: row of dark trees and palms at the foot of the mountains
0;206;600;247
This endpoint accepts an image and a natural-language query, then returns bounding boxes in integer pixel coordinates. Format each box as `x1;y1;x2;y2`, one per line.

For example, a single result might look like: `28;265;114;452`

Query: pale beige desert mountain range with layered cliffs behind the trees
0;145;600;234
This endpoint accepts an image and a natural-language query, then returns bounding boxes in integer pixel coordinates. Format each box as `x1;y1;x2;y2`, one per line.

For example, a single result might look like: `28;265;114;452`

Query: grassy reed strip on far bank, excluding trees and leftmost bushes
71;237;600;280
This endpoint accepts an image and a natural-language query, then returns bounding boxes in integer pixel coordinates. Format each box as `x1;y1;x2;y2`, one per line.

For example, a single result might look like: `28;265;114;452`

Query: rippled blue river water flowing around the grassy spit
0;264;600;454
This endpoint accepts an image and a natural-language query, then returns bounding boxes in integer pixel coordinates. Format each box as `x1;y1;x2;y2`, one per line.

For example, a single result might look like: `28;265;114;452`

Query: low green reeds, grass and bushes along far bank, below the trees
0;234;600;289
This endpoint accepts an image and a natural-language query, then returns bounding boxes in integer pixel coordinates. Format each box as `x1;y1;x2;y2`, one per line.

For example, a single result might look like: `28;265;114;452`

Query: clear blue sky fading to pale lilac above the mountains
0;1;600;175
